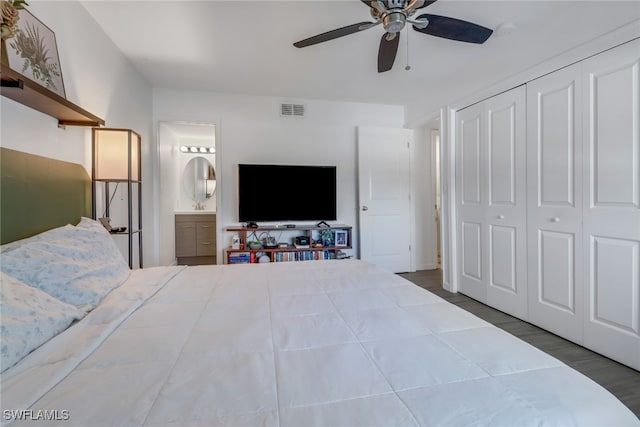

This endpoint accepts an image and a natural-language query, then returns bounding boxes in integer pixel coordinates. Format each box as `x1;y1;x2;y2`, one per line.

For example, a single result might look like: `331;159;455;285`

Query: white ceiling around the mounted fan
82;0;640;116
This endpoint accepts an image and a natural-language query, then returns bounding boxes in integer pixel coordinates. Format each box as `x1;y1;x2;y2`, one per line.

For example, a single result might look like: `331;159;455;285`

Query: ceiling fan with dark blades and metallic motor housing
293;0;493;73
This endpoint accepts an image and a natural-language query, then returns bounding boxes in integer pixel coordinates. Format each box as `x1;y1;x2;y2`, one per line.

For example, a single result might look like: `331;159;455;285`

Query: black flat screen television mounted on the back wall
238;164;336;222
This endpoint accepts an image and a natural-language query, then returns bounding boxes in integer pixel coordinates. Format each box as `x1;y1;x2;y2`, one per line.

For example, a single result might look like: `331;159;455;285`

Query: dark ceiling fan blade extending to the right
413;13;493;44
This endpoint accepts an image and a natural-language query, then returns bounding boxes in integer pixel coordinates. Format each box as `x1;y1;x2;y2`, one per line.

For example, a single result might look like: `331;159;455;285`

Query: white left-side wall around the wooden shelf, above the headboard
0;0;153;266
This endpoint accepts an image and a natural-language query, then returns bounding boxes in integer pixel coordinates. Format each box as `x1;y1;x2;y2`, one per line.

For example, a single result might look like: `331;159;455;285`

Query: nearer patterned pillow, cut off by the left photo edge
0;272;85;372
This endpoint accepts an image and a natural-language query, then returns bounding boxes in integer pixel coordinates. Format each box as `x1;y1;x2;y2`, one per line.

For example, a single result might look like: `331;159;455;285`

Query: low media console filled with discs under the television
225;224;352;264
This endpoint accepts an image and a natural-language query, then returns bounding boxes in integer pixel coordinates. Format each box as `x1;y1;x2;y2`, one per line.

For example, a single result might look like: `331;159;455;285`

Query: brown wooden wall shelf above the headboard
0;64;105;127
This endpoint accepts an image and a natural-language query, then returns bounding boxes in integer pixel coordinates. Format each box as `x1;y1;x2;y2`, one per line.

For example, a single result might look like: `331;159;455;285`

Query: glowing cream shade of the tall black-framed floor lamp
93;128;140;181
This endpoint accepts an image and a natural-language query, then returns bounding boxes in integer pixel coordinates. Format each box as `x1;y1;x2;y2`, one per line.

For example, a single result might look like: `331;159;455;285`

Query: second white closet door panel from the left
483;86;527;320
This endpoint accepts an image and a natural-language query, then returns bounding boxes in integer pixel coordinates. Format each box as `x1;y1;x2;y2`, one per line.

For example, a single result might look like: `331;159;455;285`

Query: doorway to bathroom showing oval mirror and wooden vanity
158;121;220;265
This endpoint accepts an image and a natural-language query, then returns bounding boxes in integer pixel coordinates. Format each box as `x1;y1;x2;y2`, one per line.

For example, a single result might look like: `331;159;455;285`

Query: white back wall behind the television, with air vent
153;89;404;259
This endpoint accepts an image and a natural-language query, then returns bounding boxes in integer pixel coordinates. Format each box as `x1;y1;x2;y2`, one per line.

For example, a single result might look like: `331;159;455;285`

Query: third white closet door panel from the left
527;65;583;343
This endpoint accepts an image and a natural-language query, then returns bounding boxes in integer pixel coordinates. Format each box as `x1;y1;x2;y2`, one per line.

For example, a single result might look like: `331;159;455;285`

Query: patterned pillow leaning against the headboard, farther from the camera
0;218;130;311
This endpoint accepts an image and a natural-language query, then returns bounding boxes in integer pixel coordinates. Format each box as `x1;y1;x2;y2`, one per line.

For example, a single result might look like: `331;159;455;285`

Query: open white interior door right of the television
358;126;413;273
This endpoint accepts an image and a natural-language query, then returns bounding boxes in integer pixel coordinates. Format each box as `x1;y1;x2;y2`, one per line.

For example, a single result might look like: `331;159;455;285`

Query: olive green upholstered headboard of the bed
0;148;91;244
